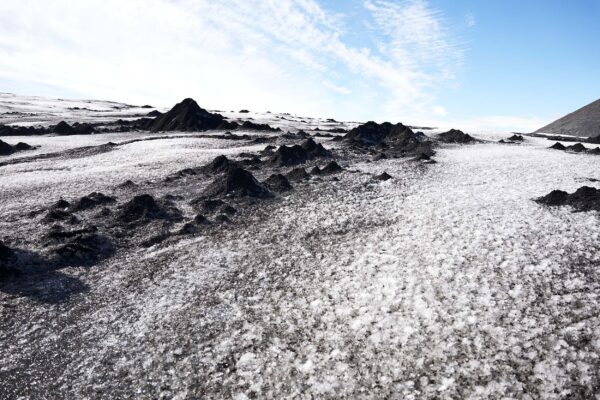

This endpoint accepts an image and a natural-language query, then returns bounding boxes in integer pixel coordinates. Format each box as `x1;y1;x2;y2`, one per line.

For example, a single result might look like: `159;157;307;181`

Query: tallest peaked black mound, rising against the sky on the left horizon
150;98;232;132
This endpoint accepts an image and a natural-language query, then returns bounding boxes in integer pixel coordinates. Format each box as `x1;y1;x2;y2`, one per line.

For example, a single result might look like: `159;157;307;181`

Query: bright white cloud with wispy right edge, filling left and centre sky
0;0;463;120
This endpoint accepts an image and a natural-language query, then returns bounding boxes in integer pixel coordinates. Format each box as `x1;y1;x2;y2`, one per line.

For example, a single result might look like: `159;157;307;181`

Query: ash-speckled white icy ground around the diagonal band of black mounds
0;98;600;399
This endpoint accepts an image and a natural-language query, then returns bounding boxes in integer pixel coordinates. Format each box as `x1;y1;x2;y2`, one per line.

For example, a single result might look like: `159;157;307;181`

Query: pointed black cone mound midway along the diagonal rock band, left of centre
203;168;273;198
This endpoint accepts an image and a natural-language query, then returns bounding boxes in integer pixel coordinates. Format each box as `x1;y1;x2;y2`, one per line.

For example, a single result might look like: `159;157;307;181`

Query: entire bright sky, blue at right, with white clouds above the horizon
0;0;600;132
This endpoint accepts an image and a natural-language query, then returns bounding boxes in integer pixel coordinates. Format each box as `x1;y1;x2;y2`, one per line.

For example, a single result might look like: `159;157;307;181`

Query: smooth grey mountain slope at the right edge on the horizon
534;99;600;137
